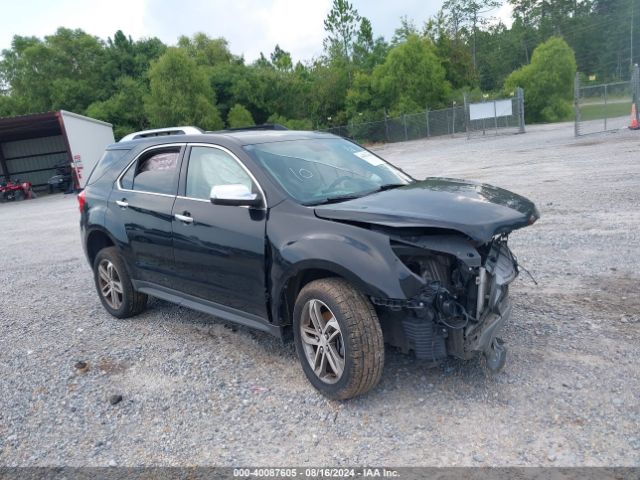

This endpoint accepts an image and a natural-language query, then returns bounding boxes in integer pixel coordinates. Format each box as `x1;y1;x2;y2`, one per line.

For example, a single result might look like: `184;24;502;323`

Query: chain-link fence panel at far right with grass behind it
574;65;639;137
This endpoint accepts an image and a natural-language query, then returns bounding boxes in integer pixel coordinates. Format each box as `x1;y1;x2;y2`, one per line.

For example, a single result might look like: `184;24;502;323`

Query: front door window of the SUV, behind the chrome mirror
186;147;256;200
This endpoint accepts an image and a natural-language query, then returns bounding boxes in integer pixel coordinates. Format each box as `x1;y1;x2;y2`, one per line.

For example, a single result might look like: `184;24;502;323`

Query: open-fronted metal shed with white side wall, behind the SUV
0;110;115;190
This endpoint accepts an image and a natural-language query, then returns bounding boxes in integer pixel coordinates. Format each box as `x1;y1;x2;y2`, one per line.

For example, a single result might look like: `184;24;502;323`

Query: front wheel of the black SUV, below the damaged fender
293;278;384;400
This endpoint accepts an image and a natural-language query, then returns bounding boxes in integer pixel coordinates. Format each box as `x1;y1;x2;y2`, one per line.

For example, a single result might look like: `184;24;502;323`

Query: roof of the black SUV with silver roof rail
114;130;334;149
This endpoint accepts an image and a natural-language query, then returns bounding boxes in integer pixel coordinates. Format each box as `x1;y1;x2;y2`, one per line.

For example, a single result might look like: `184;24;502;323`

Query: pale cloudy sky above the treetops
0;0;510;62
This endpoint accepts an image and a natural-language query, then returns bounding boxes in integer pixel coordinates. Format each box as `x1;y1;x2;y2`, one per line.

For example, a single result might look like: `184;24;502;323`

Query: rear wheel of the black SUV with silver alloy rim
93;247;147;318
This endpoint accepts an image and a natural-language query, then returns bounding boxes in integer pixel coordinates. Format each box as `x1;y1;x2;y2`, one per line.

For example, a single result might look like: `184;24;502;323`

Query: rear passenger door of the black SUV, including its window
109;144;184;287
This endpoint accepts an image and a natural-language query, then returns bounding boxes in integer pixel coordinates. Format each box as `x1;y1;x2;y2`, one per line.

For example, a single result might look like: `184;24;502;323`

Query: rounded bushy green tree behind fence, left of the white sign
372;34;451;114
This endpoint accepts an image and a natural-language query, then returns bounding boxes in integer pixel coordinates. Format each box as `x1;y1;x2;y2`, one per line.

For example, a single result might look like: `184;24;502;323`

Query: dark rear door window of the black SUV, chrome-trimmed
120;147;180;195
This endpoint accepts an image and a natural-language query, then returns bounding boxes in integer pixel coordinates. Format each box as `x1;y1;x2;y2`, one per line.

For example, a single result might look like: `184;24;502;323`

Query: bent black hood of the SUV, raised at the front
315;178;540;243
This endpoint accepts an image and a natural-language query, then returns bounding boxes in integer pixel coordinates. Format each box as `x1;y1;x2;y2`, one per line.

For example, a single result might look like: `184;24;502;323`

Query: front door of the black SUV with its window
173;146;268;319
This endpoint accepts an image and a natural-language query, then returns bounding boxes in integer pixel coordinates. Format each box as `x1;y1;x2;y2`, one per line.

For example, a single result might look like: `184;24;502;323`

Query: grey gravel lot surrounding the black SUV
0;124;640;466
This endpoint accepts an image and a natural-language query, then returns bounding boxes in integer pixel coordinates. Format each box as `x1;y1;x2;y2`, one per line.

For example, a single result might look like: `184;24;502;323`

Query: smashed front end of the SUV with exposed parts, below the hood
372;235;518;371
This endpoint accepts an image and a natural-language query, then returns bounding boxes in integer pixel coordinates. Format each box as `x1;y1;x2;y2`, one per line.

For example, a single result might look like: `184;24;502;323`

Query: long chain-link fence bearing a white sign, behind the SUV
324;89;524;143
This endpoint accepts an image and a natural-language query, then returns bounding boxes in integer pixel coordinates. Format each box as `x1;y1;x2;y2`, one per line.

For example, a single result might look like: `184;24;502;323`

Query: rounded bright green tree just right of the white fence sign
504;37;576;122
